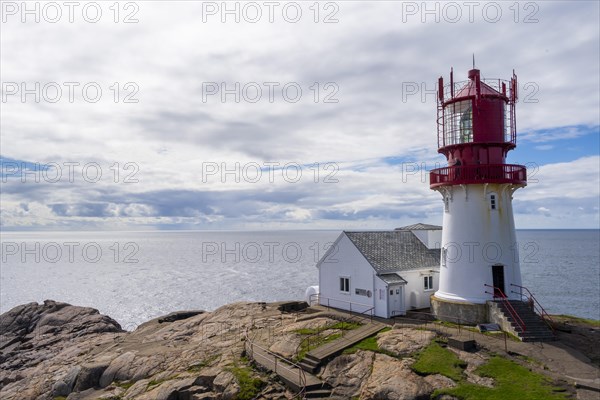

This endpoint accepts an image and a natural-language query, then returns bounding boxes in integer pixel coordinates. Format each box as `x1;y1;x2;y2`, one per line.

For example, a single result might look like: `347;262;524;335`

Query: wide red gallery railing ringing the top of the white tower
429;164;527;188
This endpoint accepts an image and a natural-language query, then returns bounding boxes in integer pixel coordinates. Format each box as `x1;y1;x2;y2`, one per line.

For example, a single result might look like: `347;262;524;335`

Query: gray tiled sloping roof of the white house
344;230;440;274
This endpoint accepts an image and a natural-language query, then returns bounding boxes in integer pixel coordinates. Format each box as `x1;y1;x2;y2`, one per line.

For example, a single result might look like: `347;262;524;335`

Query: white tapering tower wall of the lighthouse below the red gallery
435;184;521;304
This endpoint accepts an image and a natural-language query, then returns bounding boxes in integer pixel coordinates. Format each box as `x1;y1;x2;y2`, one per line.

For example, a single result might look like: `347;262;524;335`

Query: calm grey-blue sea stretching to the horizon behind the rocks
0;230;600;330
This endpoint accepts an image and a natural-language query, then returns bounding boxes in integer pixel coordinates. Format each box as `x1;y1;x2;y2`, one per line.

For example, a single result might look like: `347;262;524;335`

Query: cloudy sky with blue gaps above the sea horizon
0;1;600;230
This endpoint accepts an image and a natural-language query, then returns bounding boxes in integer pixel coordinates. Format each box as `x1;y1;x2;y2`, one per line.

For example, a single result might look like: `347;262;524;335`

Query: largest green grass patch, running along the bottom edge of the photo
432;356;570;400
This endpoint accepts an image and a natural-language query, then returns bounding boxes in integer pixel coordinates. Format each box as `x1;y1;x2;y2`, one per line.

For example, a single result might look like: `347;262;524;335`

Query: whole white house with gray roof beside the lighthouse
317;224;442;318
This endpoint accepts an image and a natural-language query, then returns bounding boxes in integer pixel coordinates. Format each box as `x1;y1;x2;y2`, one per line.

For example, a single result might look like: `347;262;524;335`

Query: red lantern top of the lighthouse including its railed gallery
430;68;526;188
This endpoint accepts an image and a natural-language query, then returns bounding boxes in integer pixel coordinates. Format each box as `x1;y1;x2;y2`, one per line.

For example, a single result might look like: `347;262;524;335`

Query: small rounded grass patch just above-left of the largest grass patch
412;341;467;381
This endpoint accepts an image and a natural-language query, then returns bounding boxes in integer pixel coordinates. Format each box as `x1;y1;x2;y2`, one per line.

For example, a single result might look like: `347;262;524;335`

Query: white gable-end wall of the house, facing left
318;233;378;312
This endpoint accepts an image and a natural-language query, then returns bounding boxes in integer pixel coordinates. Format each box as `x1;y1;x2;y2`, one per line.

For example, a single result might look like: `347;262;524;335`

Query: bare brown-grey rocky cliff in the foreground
0;300;595;400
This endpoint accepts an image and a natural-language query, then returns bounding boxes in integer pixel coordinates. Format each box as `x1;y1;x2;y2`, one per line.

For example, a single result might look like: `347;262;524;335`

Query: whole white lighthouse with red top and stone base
430;66;527;322
